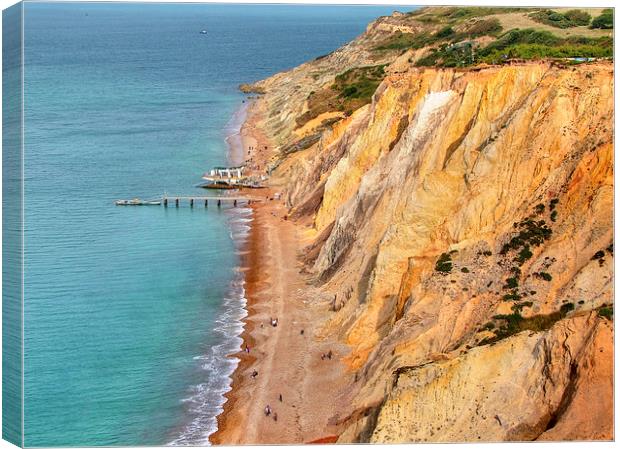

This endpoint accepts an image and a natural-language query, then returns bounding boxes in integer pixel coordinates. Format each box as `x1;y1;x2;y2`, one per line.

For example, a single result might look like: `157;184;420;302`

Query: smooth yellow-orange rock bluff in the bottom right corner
370;313;613;443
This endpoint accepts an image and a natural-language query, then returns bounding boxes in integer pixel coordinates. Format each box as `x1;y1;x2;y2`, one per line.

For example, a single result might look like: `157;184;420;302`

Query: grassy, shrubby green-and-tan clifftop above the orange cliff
374;7;613;67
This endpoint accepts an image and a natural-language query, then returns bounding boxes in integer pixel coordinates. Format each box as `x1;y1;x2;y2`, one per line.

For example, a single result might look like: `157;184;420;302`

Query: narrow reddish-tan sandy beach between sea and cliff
210;100;345;445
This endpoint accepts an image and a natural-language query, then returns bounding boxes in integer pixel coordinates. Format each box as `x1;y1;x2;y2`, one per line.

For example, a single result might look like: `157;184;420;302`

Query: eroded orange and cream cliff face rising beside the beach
245;14;613;442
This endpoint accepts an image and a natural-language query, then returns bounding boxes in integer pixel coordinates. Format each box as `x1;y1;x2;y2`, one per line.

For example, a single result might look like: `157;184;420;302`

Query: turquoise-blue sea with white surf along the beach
24;3;412;446
